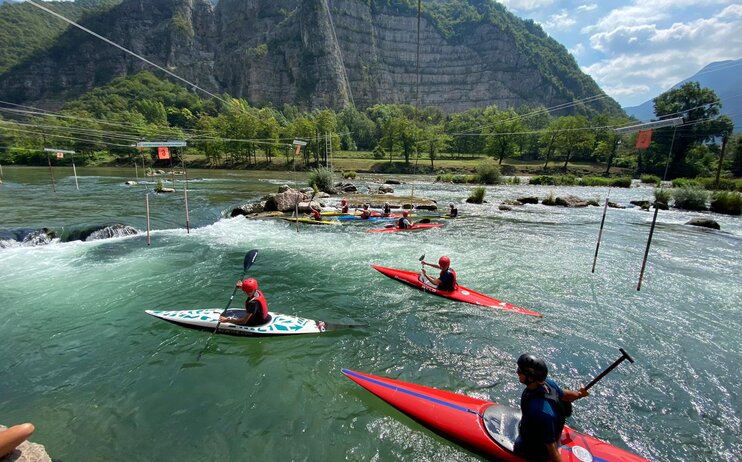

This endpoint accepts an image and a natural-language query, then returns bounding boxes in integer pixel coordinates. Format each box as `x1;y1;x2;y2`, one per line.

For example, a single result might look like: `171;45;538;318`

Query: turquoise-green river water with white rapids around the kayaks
0;167;742;461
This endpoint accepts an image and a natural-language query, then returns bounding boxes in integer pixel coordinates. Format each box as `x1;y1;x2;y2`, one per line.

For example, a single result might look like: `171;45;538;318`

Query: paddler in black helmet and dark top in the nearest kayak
513;354;589;462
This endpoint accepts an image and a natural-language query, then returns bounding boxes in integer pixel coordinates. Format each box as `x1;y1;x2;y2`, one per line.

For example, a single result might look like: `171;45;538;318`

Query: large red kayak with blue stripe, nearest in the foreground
343;369;648;462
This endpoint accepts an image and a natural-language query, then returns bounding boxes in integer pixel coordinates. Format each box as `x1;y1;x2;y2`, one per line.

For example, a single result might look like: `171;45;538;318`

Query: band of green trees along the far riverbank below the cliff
0;71;742;179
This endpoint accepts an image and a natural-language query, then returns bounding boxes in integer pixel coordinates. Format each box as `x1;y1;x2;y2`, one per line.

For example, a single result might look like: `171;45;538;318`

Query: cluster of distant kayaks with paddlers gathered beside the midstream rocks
282;198;458;233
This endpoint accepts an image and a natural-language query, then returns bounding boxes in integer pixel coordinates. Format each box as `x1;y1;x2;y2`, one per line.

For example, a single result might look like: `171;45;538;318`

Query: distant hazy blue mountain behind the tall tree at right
623;59;742;133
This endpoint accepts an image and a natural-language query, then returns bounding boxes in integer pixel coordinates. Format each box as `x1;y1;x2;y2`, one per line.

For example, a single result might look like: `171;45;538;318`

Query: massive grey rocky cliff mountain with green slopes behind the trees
0;0;621;114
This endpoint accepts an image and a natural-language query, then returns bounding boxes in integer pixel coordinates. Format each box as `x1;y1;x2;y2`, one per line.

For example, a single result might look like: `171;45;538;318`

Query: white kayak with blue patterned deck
145;308;365;335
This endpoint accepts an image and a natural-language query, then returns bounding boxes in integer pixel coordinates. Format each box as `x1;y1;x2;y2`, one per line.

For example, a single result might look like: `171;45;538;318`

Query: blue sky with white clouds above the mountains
498;0;742;107
